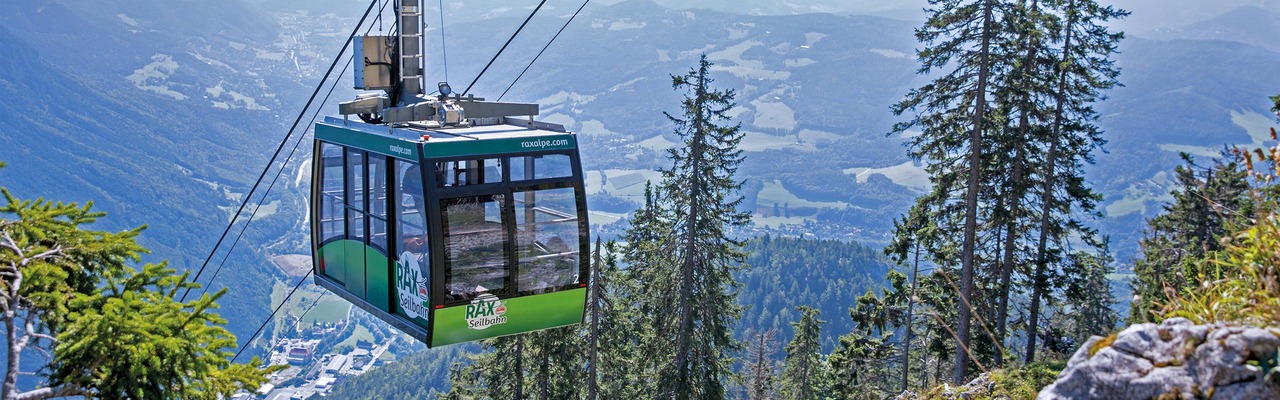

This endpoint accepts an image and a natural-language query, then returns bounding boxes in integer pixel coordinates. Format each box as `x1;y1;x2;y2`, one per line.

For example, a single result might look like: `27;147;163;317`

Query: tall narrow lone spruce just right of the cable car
640;55;749;399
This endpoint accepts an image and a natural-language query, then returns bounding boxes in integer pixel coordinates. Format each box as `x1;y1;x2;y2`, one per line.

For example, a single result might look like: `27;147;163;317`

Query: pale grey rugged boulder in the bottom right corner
1037;318;1280;400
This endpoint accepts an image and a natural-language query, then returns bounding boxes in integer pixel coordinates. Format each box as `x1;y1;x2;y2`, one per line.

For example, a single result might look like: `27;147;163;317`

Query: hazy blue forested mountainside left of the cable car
0;1;325;346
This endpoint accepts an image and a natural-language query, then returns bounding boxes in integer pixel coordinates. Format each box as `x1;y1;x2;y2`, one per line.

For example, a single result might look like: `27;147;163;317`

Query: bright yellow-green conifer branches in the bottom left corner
0;165;278;399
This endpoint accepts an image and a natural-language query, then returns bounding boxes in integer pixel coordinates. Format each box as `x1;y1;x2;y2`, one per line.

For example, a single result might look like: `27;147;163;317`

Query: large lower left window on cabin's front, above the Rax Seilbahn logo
440;195;508;300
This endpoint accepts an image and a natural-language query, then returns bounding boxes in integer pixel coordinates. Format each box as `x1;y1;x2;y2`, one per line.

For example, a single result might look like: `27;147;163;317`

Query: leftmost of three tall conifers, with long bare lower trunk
892;0;1002;383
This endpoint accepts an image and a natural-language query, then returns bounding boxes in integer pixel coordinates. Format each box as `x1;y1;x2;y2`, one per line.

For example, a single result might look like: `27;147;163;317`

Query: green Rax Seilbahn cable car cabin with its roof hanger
311;0;589;347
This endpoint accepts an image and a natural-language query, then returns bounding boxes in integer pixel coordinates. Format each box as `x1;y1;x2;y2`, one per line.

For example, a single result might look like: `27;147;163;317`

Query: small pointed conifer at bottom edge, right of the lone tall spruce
780;305;826;400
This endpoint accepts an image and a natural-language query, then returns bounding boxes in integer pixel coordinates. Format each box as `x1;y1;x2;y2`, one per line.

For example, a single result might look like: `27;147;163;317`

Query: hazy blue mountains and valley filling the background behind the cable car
0;0;1280;358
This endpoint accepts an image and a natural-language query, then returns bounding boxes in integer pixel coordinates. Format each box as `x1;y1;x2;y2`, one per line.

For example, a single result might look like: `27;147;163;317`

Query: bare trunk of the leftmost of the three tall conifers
951;0;995;385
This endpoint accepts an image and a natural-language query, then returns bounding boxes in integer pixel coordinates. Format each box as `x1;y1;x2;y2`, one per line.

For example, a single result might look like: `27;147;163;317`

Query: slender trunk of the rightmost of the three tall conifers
1024;0;1075;364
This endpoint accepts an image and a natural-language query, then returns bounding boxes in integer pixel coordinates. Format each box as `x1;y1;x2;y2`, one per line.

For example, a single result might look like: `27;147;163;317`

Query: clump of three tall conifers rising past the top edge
886;0;1126;383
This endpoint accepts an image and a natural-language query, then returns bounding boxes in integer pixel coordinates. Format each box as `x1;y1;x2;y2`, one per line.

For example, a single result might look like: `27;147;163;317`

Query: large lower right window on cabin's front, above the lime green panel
515;187;580;292
